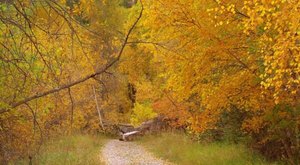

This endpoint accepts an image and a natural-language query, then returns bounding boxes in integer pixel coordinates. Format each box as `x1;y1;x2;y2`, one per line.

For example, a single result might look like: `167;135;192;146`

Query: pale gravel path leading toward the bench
102;140;171;165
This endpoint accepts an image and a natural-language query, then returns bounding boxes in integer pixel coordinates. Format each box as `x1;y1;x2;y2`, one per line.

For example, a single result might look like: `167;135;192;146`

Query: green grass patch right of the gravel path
140;133;274;165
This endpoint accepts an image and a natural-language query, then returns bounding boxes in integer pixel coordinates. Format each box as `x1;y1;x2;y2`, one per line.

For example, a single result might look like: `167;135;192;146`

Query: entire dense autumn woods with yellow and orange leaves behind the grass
0;0;300;165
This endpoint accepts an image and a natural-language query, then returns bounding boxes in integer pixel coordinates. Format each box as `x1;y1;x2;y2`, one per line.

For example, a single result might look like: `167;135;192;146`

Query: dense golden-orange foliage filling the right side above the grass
137;0;299;137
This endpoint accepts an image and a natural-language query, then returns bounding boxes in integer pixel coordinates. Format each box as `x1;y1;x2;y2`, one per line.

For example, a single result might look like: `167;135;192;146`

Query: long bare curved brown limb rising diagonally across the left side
0;0;144;114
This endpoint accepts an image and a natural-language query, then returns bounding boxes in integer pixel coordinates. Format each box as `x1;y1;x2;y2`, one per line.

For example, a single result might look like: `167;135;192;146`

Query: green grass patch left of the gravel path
14;135;106;165
